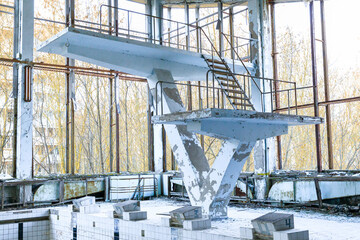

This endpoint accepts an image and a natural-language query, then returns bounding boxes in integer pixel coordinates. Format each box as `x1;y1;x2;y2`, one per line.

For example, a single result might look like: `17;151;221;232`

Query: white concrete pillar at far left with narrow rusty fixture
15;0;34;201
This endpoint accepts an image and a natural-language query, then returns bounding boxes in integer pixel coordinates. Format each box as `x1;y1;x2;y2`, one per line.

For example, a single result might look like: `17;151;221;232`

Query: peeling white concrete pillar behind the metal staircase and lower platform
248;0;276;199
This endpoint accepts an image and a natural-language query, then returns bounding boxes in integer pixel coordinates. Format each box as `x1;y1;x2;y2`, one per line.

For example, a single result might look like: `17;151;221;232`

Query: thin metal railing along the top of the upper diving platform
95;4;253;59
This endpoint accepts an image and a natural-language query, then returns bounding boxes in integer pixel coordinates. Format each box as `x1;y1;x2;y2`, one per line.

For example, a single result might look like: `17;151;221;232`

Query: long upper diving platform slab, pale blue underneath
37;27;253;81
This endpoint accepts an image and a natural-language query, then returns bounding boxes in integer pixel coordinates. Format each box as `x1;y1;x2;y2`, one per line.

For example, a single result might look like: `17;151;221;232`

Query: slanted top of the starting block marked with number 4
251;213;294;236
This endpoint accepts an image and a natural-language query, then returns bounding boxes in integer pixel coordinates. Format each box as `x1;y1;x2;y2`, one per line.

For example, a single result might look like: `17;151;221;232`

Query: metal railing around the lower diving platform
154;73;298;115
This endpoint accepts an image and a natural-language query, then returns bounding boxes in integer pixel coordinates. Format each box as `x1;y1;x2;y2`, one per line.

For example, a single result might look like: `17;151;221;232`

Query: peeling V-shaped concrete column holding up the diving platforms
148;69;255;218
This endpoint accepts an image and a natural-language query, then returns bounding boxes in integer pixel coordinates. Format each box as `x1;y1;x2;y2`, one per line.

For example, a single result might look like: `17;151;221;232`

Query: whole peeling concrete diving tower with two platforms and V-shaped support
38;23;323;218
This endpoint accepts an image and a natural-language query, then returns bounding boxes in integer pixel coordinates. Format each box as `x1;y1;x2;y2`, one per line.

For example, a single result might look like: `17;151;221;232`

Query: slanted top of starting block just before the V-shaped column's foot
170;206;202;227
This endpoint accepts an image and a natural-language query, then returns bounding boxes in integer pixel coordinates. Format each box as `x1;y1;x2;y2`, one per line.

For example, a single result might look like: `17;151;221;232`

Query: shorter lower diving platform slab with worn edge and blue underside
152;108;323;141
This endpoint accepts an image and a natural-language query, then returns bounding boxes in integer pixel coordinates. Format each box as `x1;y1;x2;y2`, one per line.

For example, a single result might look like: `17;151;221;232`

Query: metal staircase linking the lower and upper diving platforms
203;55;255;111
